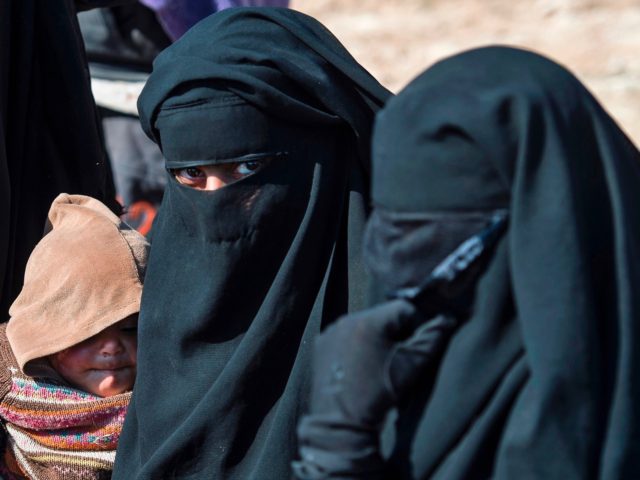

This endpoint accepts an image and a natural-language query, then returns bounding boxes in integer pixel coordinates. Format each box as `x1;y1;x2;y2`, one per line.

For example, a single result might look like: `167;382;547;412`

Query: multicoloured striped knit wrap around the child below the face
0;332;131;480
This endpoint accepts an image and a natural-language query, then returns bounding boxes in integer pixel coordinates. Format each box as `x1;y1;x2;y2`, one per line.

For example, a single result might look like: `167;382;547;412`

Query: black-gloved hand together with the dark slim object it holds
293;212;507;480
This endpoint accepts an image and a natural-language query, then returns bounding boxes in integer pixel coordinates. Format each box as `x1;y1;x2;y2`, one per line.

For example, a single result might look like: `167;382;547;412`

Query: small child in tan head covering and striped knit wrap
0;194;149;479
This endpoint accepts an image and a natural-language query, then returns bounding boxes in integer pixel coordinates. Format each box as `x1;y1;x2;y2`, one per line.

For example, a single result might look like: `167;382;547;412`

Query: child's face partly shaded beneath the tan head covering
50;314;138;397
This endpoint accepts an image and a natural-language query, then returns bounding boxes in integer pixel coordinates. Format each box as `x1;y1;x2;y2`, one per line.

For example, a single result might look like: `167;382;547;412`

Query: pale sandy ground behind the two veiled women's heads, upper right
291;0;640;146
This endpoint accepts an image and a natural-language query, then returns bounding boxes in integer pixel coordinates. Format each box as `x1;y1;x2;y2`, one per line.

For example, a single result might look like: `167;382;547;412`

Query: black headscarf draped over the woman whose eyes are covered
367;47;640;480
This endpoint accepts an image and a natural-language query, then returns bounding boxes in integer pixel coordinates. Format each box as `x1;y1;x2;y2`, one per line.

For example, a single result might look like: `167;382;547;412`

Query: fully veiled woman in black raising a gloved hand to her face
297;47;640;480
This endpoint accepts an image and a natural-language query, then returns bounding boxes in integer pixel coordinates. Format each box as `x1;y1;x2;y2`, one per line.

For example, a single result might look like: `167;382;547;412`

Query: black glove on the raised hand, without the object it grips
294;300;457;480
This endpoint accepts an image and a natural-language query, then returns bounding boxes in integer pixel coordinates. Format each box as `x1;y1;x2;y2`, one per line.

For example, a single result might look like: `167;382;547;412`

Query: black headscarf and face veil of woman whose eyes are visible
114;8;389;480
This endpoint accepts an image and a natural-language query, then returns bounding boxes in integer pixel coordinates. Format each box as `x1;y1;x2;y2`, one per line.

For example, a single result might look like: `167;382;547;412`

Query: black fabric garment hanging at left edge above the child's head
0;0;122;321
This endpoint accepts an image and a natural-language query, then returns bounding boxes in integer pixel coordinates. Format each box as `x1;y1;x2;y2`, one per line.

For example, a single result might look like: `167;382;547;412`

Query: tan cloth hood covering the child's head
7;193;149;375
